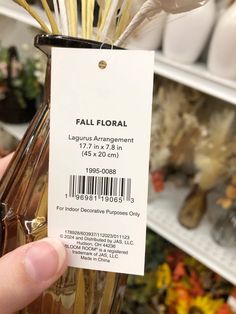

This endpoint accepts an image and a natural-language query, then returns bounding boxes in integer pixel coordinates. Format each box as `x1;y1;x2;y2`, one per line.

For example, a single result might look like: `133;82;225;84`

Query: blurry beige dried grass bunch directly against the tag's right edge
150;79;205;171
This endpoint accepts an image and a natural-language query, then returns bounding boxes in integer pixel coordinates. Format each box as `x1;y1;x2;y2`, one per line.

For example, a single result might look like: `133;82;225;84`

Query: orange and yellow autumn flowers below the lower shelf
122;230;235;314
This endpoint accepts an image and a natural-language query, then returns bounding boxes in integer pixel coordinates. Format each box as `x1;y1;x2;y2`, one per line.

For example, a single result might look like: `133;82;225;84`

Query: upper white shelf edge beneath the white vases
154;52;236;105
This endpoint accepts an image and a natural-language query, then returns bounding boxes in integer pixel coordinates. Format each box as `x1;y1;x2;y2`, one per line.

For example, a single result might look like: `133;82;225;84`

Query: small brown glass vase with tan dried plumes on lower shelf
179;110;236;228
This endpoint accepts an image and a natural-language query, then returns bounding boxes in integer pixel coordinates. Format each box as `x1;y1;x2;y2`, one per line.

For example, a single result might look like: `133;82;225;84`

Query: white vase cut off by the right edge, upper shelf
207;2;236;80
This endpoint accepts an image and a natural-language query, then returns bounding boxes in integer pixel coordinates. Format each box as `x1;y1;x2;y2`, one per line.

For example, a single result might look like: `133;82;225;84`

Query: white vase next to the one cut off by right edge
163;0;215;64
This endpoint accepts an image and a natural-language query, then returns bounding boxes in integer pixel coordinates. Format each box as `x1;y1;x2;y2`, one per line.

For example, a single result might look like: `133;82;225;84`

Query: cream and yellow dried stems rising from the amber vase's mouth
13;0;207;46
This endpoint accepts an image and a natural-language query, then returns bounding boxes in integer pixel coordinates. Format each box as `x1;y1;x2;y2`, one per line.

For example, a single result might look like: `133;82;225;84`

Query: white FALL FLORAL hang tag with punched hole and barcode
48;48;154;275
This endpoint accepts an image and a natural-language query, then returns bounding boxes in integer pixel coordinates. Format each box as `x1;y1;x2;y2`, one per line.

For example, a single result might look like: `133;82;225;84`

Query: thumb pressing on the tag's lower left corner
0;238;67;314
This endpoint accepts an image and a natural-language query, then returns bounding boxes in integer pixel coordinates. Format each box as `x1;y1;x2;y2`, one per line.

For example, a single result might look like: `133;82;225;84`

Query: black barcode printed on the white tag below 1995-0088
69;175;132;201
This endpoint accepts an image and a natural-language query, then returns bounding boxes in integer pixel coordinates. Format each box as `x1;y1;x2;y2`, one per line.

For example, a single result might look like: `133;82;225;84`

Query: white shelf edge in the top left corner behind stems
0;0;46;29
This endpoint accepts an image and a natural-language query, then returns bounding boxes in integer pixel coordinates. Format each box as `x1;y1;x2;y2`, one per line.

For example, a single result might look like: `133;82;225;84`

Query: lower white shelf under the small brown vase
147;184;236;285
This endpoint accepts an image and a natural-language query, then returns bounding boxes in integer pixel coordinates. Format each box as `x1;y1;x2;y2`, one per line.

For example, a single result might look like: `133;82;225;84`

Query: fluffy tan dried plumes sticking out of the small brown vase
194;109;236;190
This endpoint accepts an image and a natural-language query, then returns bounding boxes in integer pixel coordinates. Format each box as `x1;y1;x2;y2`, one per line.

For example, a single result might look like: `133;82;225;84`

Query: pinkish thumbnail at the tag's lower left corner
24;238;66;281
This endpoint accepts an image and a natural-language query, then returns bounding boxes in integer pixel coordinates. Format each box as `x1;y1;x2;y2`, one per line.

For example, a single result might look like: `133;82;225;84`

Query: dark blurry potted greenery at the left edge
0;46;45;123
